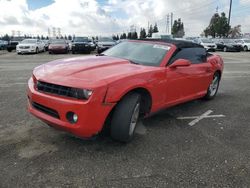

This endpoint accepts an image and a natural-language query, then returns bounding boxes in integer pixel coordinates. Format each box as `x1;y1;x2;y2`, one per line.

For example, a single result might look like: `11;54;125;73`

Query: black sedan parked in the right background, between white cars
213;39;242;52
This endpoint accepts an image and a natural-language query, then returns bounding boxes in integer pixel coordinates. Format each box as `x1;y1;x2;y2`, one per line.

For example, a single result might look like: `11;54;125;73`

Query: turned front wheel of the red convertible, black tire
110;93;141;142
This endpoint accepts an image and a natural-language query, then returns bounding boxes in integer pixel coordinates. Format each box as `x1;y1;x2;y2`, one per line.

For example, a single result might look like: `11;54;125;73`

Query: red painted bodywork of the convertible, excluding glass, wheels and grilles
28;40;223;137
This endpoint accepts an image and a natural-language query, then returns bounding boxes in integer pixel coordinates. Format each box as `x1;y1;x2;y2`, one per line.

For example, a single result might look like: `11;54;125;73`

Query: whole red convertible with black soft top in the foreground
28;40;223;142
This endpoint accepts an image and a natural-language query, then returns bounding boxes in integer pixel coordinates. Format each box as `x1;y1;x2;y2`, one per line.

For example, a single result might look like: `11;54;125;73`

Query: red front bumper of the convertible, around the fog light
27;78;115;138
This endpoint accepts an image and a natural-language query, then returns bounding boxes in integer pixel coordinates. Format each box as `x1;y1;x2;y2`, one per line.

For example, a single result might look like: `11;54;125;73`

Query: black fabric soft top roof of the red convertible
138;39;204;49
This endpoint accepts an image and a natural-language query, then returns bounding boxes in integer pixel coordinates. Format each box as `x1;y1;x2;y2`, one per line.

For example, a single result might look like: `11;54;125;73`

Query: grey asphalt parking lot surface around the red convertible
0;52;250;187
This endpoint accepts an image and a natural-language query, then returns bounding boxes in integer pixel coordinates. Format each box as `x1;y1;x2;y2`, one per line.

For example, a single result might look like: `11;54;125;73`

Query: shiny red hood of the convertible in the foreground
33;56;156;89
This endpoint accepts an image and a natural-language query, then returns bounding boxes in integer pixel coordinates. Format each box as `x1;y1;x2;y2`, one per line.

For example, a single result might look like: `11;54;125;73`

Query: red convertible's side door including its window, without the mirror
165;47;212;104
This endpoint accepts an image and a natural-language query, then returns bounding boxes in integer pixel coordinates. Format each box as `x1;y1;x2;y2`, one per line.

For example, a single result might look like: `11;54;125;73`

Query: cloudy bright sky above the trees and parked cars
0;0;250;36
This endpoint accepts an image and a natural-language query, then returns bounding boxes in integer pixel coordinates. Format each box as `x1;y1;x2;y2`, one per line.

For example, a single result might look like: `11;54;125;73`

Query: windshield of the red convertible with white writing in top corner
103;41;170;66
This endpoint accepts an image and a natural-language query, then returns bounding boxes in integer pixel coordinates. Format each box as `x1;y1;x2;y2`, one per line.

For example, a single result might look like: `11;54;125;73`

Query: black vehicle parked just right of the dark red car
72;37;92;54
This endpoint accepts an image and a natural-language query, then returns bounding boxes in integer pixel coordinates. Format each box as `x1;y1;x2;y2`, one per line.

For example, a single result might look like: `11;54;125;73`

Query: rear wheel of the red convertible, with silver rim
204;72;220;100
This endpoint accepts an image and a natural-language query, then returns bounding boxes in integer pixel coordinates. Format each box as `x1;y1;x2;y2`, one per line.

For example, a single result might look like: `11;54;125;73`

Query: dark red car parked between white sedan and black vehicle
48;39;69;54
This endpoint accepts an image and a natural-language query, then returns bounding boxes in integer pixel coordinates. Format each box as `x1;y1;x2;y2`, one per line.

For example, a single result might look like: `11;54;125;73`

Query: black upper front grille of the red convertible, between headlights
37;81;83;99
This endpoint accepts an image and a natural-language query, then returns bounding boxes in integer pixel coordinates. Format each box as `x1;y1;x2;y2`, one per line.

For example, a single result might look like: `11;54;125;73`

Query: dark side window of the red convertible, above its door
169;48;207;64
